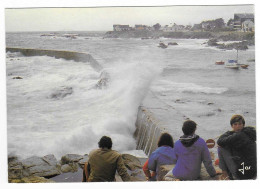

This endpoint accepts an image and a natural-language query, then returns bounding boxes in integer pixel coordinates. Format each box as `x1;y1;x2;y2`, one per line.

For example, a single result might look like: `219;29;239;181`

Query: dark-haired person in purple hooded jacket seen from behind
164;120;218;181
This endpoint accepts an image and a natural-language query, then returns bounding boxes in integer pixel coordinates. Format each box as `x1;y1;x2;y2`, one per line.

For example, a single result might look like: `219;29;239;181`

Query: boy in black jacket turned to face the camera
217;115;257;180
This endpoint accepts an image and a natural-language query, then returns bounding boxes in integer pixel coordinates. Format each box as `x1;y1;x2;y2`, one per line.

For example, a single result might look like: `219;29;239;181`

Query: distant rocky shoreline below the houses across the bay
104;31;255;50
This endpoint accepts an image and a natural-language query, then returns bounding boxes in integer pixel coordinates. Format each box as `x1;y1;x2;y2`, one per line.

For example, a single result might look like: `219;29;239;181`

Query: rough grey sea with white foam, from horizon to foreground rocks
6;31;256;158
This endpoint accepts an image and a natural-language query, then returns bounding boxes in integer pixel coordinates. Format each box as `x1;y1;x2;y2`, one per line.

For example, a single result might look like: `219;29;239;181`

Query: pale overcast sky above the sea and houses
5;5;254;31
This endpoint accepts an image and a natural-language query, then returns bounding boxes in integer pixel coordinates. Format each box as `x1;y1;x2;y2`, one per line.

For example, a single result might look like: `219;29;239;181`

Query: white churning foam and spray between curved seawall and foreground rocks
7;52;161;157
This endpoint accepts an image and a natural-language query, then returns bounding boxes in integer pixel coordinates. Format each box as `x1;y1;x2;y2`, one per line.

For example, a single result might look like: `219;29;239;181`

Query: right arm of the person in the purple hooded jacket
202;141;217;177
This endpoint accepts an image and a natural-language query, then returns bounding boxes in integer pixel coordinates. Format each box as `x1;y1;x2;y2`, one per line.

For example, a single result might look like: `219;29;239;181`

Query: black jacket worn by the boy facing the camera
217;127;257;179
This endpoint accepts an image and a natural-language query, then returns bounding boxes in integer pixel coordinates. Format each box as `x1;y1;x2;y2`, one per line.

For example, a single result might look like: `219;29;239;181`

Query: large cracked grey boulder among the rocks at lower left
21;155;60;177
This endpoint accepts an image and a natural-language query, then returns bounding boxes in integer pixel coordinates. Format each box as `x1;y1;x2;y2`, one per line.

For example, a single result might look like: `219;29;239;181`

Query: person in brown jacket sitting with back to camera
83;136;131;182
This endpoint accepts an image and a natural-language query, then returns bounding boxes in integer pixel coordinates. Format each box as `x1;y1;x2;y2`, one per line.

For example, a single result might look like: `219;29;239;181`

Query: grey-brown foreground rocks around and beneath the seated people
8;151;219;183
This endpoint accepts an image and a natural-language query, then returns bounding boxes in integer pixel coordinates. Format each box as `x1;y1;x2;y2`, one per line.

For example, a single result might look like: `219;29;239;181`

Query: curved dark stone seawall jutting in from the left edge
6;47;103;72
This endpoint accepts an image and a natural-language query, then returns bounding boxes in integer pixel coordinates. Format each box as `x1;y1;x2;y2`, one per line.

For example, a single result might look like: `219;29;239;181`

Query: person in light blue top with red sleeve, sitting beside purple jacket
143;133;174;181
